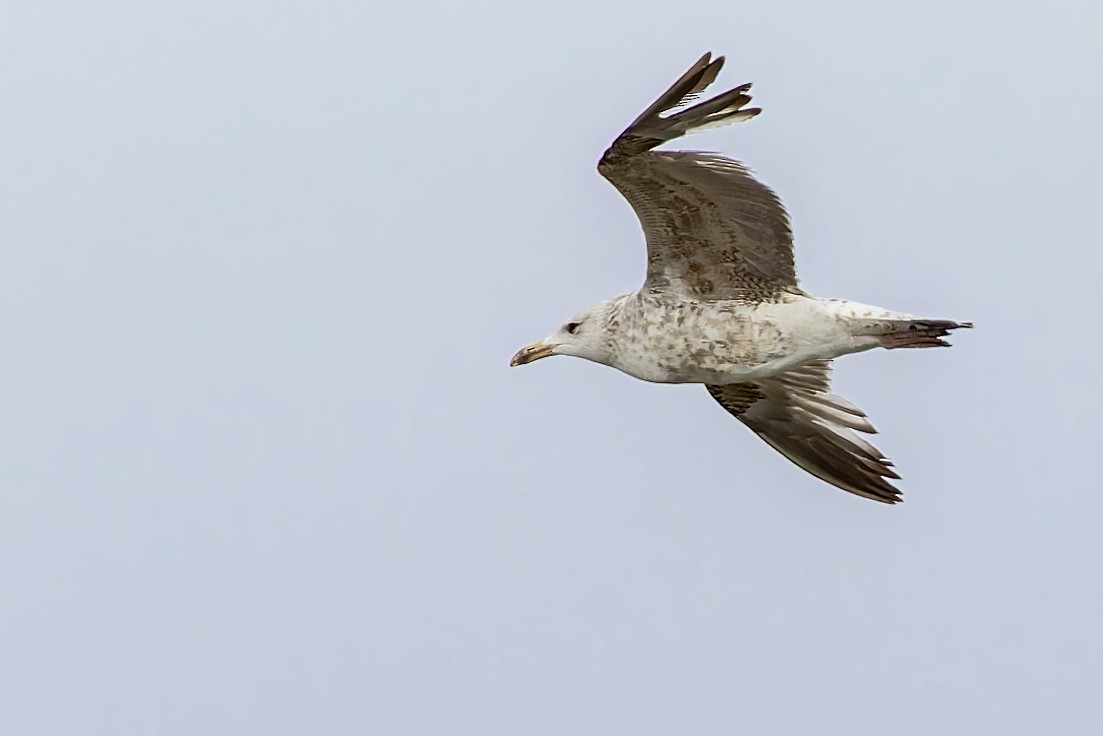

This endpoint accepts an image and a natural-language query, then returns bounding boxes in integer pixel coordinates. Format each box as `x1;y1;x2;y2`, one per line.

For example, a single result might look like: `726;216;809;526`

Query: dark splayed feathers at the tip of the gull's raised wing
606;53;762;158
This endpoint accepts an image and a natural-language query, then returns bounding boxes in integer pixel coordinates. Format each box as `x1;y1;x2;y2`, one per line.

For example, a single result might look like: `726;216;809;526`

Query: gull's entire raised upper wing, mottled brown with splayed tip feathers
598;54;802;302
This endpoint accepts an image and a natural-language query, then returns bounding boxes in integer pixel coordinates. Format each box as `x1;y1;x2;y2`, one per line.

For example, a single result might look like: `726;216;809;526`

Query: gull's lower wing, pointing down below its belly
706;361;902;503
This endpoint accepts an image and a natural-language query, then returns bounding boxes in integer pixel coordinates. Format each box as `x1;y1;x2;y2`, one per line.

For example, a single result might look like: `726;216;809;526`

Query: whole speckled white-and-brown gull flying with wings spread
511;54;973;503
